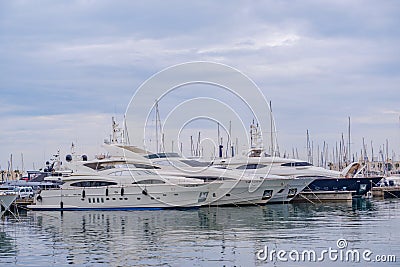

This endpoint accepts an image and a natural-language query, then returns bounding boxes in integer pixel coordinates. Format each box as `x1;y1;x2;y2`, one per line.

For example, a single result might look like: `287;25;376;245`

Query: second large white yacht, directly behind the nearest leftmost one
68;151;292;205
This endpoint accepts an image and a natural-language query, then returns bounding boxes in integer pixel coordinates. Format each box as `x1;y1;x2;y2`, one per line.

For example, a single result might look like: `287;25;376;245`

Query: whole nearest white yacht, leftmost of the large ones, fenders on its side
28;166;221;213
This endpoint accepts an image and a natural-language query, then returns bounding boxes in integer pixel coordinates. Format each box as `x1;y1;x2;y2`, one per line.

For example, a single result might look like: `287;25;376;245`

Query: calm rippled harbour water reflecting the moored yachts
0;200;400;267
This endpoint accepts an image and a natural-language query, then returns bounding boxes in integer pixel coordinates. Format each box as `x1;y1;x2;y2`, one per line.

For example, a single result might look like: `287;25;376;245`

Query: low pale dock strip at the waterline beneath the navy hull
291;191;353;203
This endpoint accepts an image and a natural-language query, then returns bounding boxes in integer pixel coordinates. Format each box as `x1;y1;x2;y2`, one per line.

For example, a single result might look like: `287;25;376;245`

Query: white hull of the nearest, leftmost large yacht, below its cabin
28;184;220;210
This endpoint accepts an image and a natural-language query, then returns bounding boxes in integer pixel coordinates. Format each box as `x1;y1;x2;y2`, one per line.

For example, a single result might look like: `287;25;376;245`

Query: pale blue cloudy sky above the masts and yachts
0;0;400;169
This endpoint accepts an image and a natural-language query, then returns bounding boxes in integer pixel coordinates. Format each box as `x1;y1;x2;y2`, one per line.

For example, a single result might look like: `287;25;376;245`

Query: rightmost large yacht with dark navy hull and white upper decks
213;122;382;202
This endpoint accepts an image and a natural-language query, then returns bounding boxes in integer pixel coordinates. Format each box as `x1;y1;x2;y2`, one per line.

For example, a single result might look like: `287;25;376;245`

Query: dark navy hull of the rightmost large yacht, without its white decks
303;177;383;197
